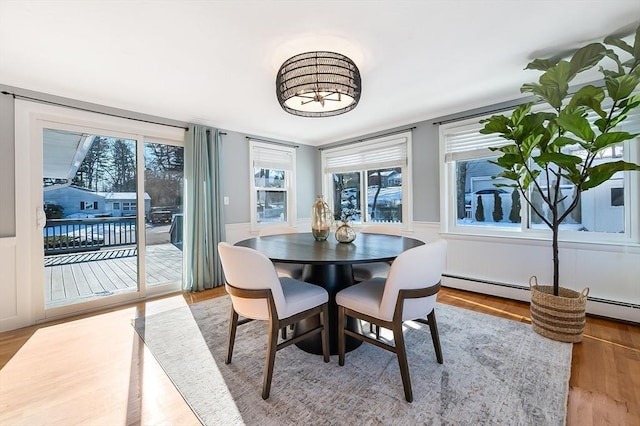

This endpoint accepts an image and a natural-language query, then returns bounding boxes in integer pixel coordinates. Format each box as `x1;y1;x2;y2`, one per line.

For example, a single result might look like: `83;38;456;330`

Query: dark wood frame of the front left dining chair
224;284;329;399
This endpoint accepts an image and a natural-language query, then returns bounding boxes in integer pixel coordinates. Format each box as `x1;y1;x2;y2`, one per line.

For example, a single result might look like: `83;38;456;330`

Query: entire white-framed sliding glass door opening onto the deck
16;99;184;320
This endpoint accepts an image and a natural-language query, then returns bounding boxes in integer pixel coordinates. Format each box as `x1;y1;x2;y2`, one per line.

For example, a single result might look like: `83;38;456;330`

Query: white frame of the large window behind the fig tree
439;115;640;244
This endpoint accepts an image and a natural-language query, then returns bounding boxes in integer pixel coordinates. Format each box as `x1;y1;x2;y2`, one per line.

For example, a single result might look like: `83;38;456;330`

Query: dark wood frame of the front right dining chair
338;283;443;402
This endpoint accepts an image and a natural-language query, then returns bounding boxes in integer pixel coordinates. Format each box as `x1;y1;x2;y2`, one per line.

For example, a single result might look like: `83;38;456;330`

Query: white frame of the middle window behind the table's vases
321;131;413;229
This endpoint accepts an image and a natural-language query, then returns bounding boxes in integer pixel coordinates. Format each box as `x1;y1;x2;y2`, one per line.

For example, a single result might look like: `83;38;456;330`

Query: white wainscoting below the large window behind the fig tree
443;230;640;323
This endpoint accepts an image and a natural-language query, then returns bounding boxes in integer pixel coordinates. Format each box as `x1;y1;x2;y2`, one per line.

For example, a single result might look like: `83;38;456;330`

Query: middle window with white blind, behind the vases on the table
322;133;411;223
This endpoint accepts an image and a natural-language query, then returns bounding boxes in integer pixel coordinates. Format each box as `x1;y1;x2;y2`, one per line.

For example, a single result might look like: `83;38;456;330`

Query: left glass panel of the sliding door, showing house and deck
42;128;142;309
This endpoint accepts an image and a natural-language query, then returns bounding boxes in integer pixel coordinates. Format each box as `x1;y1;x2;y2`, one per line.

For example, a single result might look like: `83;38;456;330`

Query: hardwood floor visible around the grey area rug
0;288;640;426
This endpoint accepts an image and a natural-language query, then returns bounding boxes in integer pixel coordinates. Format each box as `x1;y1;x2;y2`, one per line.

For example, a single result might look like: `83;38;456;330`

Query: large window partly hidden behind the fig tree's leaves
440;109;640;240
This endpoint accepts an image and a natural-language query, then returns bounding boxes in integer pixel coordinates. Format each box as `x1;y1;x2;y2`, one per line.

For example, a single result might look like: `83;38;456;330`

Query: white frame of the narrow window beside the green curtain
249;139;297;231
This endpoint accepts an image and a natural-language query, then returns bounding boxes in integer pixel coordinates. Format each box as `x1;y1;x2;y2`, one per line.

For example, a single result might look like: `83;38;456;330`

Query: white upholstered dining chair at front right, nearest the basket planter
336;240;447;402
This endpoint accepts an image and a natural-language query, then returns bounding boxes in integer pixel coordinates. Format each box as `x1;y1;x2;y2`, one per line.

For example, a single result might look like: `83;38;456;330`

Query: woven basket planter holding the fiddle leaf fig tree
529;276;589;343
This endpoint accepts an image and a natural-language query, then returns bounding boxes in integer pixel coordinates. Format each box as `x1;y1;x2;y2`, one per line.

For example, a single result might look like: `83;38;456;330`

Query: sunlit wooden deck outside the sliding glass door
44;244;182;308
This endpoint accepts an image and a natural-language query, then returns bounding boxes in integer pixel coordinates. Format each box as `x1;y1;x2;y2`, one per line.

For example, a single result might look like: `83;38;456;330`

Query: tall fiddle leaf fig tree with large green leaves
480;27;640;296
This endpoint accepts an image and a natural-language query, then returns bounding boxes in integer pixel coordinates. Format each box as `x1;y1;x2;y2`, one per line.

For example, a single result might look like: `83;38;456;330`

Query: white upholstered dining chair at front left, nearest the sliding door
218;242;329;399
